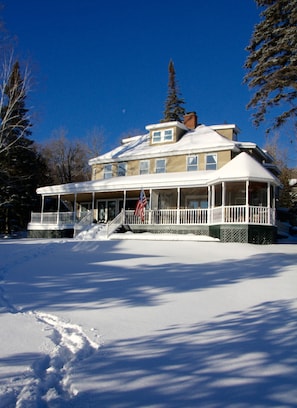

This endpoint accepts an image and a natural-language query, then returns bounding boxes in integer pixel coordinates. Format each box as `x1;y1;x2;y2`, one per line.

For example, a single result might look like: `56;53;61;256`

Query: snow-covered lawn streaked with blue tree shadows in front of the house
0;235;297;408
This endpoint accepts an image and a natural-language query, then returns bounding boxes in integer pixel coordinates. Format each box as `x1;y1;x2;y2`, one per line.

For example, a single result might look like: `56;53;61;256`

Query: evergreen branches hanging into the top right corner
244;0;297;132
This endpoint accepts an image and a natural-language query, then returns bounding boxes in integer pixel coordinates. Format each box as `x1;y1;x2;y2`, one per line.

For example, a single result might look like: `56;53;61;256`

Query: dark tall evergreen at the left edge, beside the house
0;62;44;234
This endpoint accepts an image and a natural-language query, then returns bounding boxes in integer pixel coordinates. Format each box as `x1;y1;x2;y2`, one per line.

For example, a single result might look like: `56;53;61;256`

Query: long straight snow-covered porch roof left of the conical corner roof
37;170;216;196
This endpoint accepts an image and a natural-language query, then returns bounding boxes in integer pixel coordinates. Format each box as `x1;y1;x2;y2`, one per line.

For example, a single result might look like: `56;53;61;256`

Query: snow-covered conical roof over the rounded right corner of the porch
211;152;280;185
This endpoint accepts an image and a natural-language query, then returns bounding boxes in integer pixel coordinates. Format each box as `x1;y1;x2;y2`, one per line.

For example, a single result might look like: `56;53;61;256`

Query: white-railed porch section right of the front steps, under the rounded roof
124;181;275;225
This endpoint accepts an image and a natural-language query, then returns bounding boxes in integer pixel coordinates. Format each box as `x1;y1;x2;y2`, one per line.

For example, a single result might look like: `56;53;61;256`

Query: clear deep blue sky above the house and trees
1;0;265;150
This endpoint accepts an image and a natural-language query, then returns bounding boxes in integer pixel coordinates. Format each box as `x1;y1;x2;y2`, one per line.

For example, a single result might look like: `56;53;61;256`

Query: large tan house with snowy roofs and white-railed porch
28;112;279;243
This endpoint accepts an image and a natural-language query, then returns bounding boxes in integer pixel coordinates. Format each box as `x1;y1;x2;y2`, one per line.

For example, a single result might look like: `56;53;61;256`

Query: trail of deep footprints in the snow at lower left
12;312;99;408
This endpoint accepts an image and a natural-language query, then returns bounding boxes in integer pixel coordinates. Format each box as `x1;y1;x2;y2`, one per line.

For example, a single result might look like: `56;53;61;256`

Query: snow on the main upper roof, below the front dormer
89;125;237;165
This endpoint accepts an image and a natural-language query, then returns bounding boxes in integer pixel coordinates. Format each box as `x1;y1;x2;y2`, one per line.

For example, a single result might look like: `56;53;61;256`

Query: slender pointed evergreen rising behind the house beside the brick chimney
162;60;185;122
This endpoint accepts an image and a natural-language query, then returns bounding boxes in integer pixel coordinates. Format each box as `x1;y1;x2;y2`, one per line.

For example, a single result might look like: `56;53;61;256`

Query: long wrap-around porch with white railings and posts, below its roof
29;180;275;234
